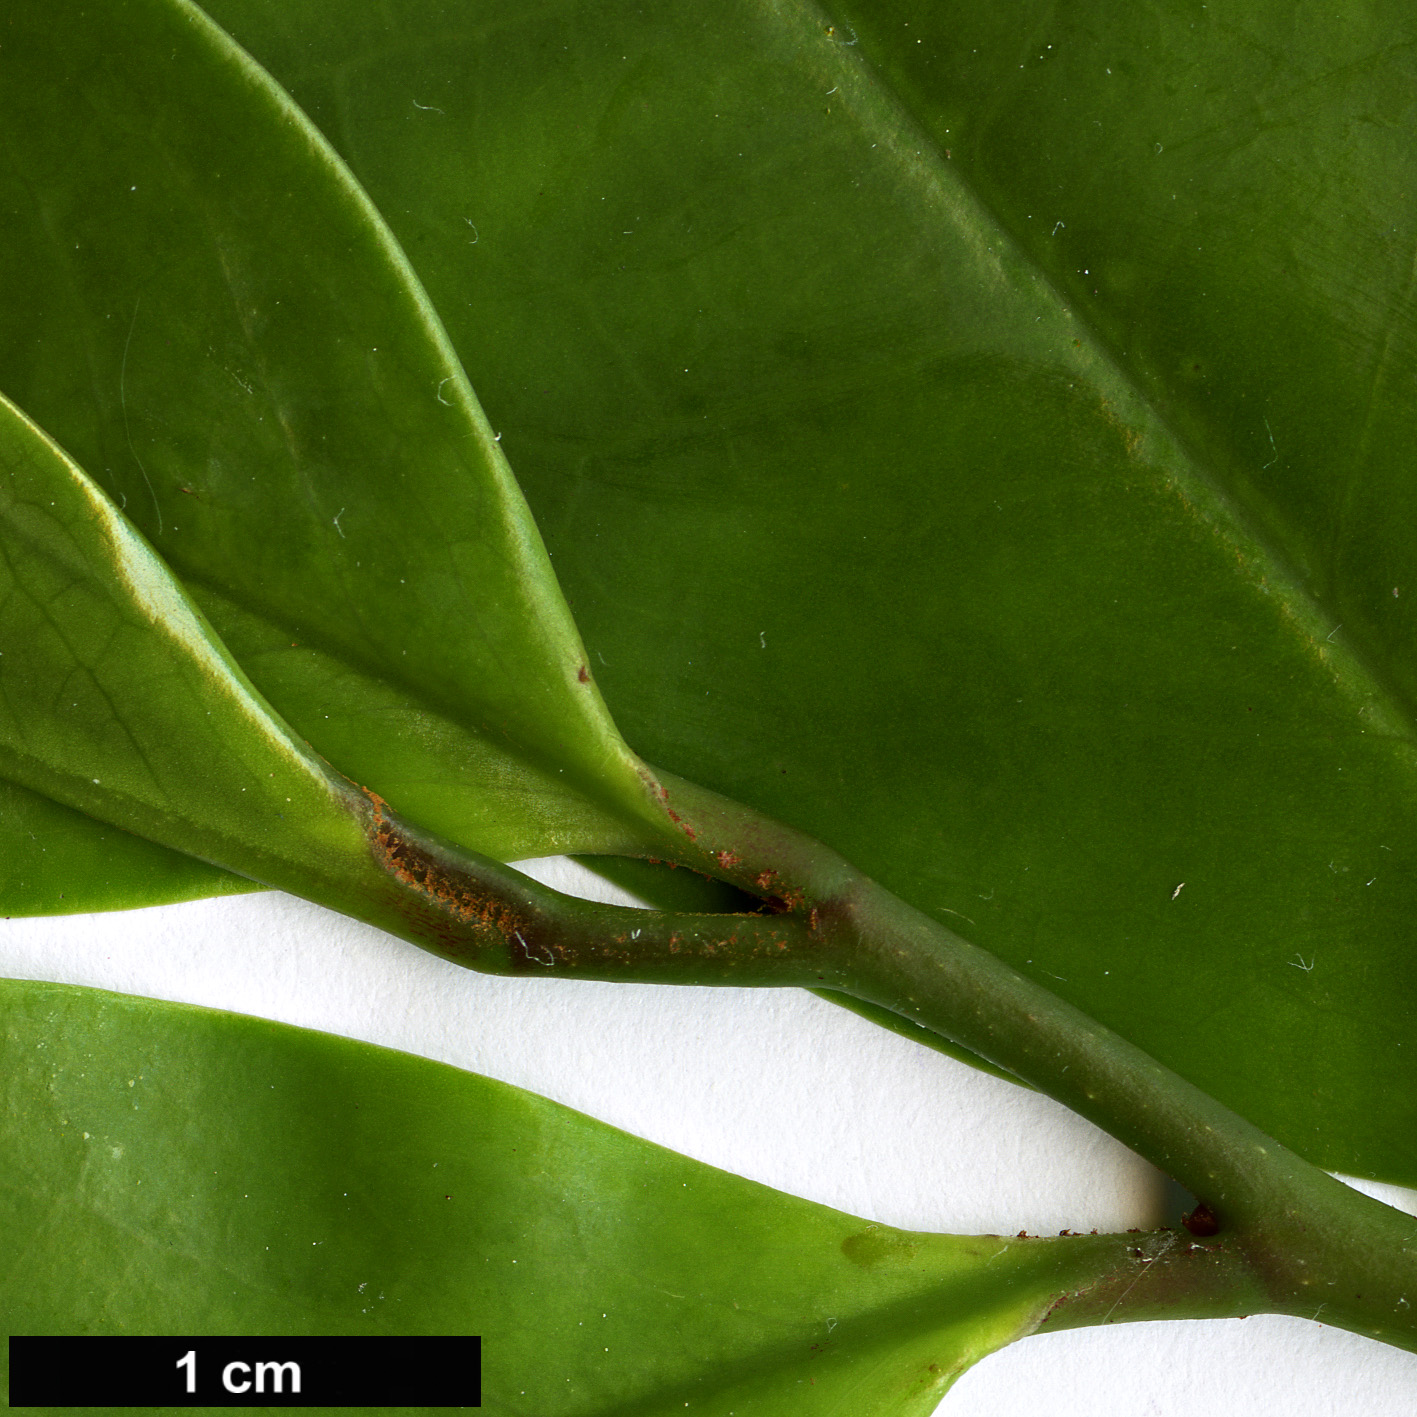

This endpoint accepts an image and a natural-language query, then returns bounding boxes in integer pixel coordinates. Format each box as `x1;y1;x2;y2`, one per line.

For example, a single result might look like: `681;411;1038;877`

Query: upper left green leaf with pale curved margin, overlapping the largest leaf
0;0;680;908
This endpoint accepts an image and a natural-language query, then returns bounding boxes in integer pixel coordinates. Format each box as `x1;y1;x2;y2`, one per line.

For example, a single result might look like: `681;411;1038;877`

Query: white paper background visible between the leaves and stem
0;862;1417;1417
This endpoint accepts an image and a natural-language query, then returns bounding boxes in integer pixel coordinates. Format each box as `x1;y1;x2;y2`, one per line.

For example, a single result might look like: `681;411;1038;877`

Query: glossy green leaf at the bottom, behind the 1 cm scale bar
0;981;1132;1417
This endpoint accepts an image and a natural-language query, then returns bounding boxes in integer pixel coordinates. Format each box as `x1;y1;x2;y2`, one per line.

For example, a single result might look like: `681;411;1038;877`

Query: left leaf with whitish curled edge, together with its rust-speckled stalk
0;385;827;985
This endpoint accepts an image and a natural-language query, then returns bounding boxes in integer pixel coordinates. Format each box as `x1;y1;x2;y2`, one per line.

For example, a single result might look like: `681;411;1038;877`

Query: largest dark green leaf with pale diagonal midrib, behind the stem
202;0;1417;1182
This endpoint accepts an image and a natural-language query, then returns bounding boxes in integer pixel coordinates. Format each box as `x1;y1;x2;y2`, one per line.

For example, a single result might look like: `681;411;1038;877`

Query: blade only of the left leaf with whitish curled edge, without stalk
0;388;368;890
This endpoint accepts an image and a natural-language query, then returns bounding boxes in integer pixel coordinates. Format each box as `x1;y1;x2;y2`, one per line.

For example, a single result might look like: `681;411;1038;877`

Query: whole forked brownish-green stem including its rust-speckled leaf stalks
318;777;1417;1349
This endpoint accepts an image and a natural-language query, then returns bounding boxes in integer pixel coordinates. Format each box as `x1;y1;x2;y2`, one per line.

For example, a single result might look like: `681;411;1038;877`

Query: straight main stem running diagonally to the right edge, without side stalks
648;777;1417;1349
